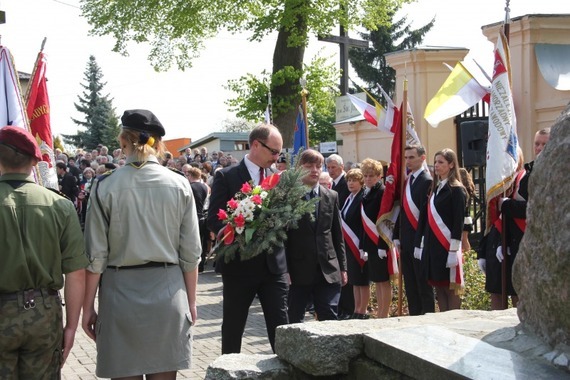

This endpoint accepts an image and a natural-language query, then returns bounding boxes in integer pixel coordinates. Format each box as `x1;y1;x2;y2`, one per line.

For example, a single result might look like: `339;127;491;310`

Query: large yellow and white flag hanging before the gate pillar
424;62;488;128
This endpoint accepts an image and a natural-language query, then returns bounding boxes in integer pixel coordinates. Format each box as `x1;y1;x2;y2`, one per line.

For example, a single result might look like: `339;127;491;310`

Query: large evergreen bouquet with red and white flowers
214;168;318;262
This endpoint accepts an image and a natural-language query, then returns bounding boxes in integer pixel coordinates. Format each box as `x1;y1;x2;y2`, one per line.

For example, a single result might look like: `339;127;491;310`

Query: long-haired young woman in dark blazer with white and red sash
414;148;466;311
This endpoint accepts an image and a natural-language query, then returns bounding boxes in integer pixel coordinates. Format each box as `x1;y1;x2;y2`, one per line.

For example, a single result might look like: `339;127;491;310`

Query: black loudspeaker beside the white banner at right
459;120;489;167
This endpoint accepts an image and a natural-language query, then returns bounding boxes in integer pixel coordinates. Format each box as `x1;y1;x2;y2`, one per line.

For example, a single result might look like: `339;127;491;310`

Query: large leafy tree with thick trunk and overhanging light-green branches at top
81;0;413;145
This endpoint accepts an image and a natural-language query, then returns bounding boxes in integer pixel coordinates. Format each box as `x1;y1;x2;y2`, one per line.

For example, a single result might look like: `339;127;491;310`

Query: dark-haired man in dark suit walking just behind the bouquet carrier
286;149;347;323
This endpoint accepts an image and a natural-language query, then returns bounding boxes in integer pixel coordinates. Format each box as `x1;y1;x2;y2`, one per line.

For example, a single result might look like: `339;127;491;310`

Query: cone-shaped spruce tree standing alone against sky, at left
63;56;120;151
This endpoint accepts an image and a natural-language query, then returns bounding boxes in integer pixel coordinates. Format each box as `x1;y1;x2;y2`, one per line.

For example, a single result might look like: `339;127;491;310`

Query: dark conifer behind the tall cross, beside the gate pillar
349;9;435;102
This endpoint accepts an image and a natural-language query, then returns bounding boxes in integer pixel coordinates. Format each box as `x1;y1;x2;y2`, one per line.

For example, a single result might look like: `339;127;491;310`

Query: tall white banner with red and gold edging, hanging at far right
485;31;518;230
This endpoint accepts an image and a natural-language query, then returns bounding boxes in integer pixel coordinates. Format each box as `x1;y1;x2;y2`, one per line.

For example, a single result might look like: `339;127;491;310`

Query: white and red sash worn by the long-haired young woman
427;194;465;294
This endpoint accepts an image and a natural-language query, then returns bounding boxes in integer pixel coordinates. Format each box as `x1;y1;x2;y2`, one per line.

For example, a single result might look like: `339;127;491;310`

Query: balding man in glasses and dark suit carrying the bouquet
207;124;289;354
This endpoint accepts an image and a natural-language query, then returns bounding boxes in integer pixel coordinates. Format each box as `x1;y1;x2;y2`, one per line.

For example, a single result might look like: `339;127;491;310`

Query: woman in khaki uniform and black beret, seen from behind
82;110;201;380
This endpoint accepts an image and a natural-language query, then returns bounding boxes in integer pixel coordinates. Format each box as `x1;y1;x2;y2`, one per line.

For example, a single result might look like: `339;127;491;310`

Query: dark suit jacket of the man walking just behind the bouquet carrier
286;186;346;285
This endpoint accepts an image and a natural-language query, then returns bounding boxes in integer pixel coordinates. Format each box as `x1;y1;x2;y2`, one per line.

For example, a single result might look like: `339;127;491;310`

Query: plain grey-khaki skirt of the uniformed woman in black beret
96;265;192;378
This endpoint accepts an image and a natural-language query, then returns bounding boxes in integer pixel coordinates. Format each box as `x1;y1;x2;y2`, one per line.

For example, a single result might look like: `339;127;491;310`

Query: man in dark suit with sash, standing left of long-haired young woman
394;145;435;315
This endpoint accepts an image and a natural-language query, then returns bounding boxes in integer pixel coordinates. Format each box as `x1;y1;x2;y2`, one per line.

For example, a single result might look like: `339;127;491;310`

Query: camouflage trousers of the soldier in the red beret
0;292;63;380
